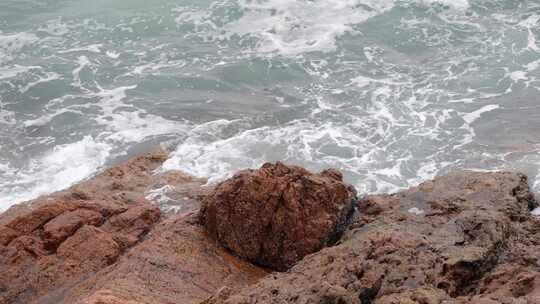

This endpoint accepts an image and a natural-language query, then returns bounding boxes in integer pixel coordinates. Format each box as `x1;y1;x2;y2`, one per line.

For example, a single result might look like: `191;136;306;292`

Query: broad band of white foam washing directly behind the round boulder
162;99;451;193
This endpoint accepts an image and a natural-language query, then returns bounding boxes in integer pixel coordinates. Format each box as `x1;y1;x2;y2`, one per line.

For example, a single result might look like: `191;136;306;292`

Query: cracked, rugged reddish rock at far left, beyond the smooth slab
0;154;173;303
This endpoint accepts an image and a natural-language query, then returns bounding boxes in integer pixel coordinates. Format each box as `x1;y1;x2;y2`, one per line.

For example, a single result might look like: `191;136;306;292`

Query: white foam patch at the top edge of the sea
176;0;394;56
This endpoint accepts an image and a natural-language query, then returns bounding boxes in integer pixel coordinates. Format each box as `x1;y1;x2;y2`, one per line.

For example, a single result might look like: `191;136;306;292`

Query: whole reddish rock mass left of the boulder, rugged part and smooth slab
0;153;267;304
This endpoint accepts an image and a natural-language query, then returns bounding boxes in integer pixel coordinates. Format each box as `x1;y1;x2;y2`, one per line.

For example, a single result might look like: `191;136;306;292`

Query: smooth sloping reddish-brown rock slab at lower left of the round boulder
64;214;267;304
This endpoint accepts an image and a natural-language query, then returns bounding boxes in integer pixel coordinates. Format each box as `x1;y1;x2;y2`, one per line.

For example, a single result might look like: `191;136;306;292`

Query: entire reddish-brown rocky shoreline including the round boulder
0;151;540;304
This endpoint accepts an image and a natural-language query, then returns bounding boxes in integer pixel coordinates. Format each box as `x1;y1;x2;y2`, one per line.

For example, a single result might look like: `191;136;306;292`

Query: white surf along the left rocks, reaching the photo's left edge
0;80;187;211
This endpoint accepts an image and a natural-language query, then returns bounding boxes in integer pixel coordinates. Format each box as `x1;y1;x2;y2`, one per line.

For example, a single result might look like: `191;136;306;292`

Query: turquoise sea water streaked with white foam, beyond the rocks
0;0;540;209
